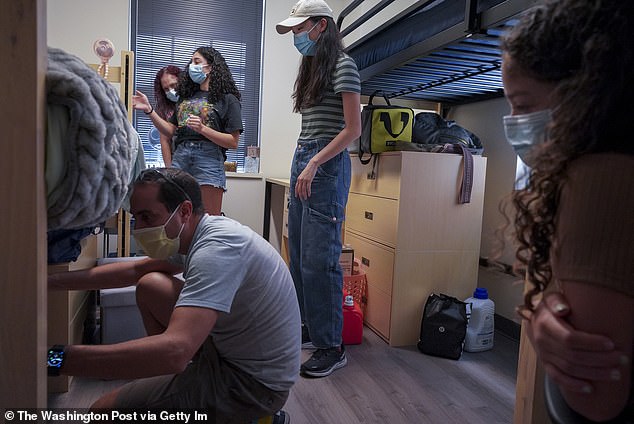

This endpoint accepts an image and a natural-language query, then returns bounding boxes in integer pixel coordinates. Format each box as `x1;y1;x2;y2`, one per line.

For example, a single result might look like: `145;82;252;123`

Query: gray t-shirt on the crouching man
175;215;301;391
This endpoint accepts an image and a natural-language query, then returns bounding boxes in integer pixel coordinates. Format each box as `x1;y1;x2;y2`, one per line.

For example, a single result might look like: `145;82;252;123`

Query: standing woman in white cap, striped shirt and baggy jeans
276;0;361;377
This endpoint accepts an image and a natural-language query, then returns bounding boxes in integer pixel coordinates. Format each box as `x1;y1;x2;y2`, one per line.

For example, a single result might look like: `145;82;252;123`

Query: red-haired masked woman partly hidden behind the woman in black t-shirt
154;65;181;167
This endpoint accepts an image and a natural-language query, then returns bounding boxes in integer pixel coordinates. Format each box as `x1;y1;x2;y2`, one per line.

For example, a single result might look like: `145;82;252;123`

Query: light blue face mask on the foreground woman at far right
503;109;551;166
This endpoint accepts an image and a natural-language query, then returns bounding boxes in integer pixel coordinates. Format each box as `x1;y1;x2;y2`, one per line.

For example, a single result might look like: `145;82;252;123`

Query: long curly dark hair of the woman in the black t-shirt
179;47;241;103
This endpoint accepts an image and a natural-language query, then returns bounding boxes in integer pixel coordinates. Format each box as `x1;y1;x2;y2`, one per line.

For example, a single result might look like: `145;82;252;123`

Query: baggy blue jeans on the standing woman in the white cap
288;139;350;349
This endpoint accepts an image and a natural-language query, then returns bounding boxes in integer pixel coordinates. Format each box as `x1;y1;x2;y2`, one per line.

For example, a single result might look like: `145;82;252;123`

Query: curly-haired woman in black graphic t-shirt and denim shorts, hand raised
132;47;243;215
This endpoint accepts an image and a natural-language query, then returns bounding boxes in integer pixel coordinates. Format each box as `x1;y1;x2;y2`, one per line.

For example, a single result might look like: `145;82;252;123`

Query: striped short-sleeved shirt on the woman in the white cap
299;53;361;140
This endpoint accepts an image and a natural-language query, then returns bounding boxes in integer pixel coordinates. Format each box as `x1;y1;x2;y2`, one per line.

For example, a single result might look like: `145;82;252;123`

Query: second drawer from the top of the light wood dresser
346;193;398;247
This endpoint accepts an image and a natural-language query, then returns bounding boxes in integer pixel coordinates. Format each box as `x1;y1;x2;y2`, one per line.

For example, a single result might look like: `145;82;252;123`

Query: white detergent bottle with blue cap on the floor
464;287;495;352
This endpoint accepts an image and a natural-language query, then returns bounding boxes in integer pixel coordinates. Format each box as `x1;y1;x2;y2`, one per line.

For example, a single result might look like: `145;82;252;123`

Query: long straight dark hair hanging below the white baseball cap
293;16;343;112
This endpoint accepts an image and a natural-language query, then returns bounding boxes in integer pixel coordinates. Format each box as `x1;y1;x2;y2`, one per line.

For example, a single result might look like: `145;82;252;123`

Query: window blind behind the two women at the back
130;0;263;172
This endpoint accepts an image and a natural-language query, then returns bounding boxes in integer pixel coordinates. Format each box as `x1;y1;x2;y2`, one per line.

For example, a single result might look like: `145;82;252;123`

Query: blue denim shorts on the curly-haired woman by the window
172;141;227;191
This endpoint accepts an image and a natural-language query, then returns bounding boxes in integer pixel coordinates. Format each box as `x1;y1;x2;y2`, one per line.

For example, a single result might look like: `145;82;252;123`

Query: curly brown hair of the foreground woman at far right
501;0;634;310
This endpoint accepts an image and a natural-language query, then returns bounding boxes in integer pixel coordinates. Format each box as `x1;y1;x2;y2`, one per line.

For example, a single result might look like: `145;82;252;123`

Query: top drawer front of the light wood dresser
350;153;401;199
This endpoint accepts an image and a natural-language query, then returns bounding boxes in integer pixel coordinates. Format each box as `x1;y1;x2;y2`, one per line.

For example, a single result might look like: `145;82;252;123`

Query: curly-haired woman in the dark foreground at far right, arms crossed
502;0;634;422
